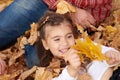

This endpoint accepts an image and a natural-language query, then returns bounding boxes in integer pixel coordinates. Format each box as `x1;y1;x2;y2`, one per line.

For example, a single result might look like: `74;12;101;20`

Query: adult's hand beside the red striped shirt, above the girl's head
70;8;96;28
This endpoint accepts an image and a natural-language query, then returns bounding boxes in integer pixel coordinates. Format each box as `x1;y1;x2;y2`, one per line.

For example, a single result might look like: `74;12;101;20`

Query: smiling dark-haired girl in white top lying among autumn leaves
37;13;120;80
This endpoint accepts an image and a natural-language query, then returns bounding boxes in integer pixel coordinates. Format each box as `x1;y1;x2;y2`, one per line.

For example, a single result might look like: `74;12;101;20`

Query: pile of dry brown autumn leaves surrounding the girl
0;0;120;80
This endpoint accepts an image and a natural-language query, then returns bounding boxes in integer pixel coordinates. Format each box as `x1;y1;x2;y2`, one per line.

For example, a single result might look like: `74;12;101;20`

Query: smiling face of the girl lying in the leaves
42;23;75;58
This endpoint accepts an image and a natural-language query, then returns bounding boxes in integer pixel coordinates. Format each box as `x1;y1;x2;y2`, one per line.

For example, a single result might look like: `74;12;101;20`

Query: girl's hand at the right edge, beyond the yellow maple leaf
105;50;120;65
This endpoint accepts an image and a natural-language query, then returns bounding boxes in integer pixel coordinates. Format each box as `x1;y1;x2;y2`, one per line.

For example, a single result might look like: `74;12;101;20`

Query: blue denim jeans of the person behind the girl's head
0;0;48;68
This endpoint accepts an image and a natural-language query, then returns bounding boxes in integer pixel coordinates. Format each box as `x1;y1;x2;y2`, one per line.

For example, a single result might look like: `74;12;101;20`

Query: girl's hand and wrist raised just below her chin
65;49;81;77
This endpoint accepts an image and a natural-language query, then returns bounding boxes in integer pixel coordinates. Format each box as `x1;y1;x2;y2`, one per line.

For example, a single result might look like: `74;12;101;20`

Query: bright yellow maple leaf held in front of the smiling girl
72;36;107;62
